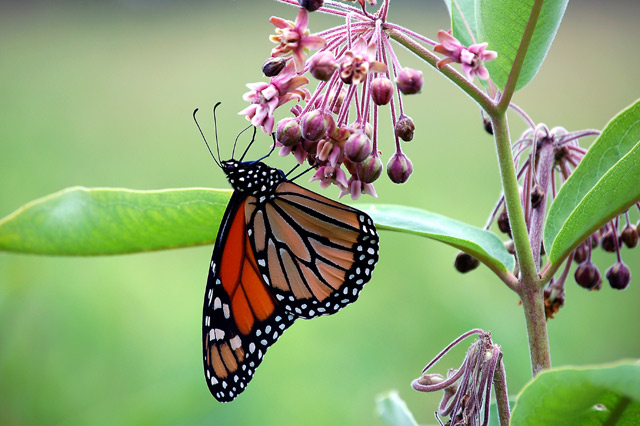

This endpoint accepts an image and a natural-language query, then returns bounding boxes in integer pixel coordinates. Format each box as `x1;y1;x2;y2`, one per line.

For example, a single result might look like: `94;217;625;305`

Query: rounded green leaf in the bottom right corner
511;361;640;426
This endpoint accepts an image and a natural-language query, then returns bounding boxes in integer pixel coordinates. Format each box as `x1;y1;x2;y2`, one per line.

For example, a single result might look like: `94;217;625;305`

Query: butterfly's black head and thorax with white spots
221;159;287;196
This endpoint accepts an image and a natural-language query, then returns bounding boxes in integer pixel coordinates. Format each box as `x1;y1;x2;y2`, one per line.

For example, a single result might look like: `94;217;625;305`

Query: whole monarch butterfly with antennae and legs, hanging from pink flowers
193;103;378;402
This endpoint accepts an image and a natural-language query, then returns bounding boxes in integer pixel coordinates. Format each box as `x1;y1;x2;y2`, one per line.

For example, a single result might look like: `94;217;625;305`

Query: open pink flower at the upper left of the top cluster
269;8;325;72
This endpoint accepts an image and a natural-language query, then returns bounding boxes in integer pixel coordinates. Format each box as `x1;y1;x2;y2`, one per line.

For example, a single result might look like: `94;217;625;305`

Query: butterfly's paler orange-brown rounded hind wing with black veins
246;182;378;318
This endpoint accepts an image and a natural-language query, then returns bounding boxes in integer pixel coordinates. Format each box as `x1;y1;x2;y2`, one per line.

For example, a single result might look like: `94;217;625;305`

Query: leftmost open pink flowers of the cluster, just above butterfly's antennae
238;62;309;134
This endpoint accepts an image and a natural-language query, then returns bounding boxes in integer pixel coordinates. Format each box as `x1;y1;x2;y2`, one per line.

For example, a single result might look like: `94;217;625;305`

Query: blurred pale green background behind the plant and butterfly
0;0;640;425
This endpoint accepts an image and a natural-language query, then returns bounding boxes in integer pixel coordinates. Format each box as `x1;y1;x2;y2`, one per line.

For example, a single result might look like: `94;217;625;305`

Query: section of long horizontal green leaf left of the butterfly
0;187;231;256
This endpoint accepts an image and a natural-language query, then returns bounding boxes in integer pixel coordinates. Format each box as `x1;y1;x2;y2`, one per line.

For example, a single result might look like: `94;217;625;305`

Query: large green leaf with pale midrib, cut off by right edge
544;101;640;263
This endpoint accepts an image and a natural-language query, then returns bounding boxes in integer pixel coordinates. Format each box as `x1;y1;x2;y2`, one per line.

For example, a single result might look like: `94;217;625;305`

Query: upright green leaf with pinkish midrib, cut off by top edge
475;0;569;90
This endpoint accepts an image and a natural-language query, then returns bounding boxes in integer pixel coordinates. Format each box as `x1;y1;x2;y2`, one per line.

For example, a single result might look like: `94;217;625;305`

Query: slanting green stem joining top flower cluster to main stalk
387;29;496;115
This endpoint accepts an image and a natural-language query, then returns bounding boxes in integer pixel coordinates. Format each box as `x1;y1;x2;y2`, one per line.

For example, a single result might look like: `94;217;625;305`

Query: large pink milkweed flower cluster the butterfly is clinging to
240;0;495;199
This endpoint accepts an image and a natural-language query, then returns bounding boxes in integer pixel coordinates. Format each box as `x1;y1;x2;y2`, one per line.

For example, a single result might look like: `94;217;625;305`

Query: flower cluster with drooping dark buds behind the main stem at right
464;116;640;318
